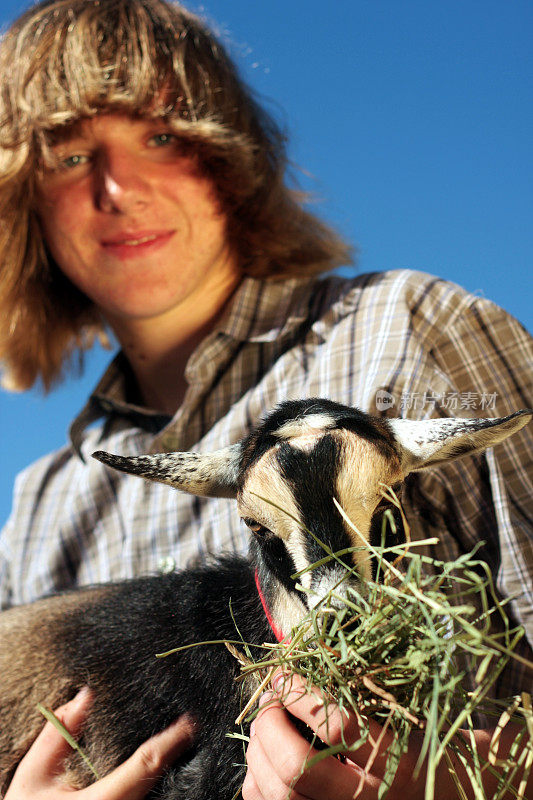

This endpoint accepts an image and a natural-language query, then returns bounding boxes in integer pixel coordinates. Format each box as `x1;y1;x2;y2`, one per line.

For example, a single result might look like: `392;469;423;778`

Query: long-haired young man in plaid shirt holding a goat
0;0;533;800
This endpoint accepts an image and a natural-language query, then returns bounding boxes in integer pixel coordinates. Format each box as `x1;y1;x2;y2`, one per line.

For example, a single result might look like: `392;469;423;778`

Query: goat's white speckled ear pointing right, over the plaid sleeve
388;409;533;475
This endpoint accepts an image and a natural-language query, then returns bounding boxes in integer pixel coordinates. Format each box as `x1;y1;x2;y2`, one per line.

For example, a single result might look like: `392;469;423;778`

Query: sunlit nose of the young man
94;151;151;214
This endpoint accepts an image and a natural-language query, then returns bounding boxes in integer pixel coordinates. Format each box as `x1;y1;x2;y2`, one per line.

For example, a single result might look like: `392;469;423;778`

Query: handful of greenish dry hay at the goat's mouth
233;510;533;800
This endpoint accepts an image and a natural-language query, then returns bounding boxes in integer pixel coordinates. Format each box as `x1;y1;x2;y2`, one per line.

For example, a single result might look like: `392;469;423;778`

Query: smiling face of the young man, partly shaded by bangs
37;114;237;327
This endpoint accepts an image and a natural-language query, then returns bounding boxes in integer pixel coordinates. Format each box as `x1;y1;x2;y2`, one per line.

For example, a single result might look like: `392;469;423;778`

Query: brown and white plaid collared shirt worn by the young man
0;270;533;694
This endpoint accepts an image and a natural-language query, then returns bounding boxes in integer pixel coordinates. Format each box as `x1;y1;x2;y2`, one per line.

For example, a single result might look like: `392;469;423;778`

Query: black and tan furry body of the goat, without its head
0;557;266;800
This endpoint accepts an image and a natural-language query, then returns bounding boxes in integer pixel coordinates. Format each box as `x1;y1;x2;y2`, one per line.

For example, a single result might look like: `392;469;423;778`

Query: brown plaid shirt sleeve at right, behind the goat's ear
404;284;533;691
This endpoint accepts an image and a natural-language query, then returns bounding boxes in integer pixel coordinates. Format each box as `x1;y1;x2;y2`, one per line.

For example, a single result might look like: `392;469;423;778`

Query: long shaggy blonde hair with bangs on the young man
0;0;350;390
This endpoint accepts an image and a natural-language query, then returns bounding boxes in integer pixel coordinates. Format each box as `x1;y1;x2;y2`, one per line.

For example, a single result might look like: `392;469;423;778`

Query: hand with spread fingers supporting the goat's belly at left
4;688;194;800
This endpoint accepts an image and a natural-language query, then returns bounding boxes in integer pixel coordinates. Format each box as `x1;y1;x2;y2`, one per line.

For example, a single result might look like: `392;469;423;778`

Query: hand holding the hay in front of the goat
242;674;490;800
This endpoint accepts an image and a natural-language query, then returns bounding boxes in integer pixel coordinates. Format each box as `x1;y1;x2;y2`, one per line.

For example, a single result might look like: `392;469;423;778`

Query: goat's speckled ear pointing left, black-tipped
93;444;241;497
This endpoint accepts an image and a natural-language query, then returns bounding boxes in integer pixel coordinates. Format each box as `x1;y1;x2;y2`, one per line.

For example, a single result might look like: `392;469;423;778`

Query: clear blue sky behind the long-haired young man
0;0;533;524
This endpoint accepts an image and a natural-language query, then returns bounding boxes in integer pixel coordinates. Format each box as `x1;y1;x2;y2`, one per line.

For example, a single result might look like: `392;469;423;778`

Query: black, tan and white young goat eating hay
0;399;533;800
